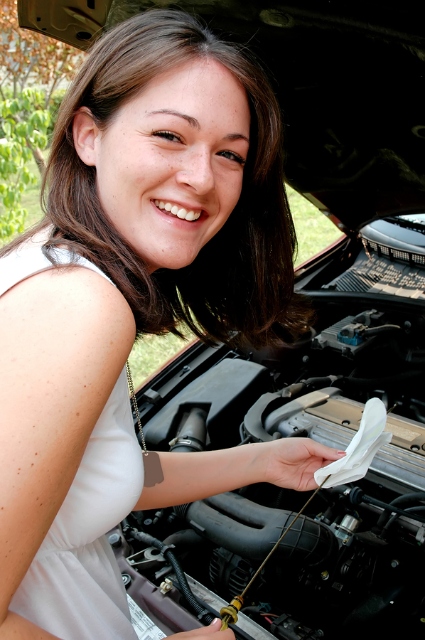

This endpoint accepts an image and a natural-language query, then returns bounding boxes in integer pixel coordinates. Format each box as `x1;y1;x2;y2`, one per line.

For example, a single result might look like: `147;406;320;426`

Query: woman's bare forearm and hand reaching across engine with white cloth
136;438;345;509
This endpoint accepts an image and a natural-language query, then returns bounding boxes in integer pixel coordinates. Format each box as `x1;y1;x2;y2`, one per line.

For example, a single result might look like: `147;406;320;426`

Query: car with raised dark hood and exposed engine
19;0;425;640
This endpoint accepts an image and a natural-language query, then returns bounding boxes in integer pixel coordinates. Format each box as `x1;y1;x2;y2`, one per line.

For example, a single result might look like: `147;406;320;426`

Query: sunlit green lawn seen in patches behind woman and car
4;166;341;388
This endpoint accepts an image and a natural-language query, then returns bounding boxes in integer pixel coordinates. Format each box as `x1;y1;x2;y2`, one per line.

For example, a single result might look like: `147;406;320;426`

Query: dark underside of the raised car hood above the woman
18;0;425;232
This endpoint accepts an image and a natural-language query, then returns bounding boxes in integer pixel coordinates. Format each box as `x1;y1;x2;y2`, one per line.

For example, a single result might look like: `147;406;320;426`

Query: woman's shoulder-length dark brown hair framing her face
4;9;309;346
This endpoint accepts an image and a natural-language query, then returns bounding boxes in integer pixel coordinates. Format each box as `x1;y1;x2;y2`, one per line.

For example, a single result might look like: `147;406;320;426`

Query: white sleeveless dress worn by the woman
0;241;143;640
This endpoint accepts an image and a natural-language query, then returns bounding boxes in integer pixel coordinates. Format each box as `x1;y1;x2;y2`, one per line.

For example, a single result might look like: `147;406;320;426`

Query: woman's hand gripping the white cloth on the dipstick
263;438;345;491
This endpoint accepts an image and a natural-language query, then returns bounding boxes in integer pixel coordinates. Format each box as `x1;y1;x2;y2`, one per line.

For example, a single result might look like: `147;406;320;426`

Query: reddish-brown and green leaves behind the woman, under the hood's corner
0;0;83;241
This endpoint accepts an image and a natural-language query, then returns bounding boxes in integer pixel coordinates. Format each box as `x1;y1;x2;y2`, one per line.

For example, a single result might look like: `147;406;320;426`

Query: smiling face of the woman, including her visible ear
74;59;250;271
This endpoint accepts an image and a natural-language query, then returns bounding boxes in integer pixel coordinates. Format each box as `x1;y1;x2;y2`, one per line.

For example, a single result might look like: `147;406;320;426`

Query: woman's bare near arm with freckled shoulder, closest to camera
0;268;135;638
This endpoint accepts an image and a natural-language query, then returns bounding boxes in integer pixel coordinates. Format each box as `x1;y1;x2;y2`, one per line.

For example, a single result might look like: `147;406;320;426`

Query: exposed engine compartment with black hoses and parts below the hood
113;236;425;640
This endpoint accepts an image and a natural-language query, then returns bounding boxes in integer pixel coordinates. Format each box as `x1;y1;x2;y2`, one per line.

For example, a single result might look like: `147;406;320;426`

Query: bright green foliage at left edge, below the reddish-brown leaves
0;88;52;242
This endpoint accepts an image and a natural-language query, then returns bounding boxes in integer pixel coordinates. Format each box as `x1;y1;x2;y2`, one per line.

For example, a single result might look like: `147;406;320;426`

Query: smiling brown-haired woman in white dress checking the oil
0;10;342;640
